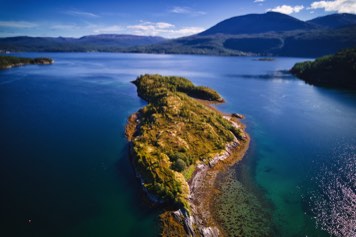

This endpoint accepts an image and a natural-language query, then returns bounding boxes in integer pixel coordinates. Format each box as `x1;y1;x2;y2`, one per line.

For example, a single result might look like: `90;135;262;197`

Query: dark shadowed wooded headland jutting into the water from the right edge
290;48;356;89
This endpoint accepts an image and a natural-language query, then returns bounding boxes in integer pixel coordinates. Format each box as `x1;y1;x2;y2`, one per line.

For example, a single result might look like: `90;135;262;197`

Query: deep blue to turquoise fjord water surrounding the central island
0;53;356;236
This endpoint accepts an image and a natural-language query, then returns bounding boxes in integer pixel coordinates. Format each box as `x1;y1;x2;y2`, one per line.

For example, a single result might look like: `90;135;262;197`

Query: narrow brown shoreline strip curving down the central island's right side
188;101;250;236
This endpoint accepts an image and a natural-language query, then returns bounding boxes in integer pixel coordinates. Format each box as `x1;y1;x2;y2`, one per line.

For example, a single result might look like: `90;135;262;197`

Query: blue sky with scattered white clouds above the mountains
0;0;356;38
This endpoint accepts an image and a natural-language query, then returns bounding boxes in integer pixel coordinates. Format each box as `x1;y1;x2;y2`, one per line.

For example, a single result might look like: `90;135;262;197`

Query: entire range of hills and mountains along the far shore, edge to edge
0;12;356;57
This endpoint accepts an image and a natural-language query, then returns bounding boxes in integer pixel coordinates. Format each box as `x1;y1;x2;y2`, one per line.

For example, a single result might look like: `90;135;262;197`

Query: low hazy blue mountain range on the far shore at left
0;34;165;52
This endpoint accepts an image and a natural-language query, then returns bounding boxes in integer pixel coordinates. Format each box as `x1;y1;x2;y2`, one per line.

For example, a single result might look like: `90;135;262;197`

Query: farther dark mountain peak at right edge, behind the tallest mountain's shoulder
307;13;356;28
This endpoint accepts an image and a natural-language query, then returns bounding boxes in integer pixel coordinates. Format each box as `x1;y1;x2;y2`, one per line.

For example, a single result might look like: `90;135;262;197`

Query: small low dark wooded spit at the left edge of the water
0;56;54;69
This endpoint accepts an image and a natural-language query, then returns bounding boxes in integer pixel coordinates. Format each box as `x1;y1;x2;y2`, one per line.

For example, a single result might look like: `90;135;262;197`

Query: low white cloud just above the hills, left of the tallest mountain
127;21;204;38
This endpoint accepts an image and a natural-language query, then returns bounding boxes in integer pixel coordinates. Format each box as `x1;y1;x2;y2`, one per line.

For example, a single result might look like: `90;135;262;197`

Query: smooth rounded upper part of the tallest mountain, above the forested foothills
199;12;317;35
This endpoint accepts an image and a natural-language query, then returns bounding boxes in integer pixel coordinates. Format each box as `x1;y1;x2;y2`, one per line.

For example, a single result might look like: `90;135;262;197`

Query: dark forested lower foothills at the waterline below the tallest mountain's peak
133;26;356;57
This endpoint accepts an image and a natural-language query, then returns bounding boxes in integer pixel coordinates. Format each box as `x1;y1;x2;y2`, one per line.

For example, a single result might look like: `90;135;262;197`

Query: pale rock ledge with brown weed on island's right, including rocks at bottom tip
173;116;249;237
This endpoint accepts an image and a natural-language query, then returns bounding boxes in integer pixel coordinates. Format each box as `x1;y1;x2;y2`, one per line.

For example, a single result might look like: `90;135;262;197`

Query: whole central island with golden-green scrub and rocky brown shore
126;74;249;236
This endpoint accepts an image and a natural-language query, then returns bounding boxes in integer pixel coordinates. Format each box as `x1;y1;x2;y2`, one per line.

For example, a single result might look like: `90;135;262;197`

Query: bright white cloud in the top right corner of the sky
310;0;356;14
